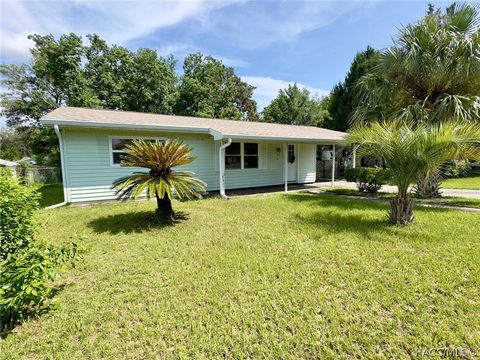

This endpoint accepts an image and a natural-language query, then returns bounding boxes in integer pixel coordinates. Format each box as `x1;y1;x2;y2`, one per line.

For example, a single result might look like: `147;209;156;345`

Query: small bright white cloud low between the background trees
242;76;329;110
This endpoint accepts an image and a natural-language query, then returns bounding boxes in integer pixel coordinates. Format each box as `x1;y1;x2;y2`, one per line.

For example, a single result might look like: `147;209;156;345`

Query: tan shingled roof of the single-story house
40;107;346;143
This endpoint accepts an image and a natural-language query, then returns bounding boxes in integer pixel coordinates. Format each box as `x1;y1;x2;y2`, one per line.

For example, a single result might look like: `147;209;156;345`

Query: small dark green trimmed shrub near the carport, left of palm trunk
345;167;391;193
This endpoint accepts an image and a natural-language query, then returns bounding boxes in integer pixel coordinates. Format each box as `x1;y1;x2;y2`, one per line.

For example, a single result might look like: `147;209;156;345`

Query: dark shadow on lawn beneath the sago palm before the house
87;211;188;235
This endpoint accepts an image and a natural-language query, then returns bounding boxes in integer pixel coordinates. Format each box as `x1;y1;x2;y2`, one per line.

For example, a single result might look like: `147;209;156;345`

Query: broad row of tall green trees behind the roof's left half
0;33;257;125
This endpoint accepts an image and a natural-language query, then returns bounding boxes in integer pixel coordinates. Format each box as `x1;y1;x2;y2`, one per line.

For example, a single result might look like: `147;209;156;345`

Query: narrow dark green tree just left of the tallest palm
323;46;379;131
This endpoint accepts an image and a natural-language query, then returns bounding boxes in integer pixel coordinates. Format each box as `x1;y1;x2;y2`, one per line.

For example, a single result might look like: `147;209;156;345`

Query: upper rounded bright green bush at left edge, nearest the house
0;172;39;259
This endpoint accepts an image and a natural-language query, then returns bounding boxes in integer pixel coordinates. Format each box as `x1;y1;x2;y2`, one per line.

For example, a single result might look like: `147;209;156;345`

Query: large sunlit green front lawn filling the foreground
1;193;480;359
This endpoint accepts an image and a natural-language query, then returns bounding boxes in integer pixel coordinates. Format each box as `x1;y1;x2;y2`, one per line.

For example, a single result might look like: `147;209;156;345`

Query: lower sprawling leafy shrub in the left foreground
0;241;77;332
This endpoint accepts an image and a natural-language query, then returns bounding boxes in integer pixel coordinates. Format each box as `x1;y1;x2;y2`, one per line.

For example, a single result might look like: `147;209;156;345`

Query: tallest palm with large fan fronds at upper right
351;3;480;195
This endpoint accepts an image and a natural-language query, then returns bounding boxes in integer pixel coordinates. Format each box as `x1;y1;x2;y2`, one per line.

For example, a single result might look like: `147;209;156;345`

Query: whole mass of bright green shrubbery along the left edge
0;171;77;334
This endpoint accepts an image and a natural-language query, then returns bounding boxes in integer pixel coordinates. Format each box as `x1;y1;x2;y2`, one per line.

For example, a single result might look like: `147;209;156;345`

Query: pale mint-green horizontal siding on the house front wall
62;128;315;202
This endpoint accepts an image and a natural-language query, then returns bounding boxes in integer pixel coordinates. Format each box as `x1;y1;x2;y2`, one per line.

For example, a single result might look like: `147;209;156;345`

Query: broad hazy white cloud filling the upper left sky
0;0;225;60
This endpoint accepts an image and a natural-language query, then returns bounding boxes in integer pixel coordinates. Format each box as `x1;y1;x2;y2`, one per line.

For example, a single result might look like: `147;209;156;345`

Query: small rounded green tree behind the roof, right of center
263;84;327;126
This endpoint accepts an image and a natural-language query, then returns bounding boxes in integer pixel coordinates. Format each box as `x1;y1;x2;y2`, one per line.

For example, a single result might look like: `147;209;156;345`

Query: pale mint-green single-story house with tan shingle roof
41;107;345;203
